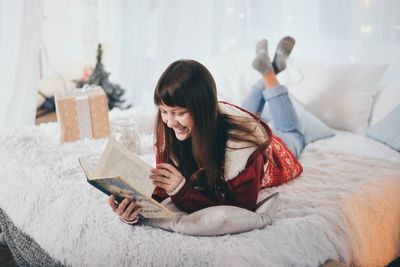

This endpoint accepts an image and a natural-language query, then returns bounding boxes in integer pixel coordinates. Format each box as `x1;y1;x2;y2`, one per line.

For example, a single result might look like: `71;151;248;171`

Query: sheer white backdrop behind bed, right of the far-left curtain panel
42;0;400;107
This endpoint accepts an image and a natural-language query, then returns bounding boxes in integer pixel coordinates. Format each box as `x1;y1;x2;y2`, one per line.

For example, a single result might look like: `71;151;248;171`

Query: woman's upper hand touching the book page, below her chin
150;163;184;193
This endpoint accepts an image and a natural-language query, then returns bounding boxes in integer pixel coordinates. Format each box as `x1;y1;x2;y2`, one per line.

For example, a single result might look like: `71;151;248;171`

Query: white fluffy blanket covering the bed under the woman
0;109;400;266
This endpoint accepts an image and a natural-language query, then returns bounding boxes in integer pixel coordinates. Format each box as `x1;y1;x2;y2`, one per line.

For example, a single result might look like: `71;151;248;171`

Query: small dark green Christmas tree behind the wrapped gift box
73;44;131;110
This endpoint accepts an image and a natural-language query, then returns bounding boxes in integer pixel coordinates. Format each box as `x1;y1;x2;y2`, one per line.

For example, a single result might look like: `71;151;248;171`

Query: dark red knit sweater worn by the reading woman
153;102;303;213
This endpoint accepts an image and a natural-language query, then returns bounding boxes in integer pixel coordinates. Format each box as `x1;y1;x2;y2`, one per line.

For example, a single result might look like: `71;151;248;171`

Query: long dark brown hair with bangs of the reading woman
154;60;265;199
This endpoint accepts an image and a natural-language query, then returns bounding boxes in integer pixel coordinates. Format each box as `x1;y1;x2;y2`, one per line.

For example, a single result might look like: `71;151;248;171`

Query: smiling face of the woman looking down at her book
159;104;194;141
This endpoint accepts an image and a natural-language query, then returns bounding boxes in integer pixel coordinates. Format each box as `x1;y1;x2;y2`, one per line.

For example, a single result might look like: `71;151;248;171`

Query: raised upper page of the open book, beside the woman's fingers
95;137;155;197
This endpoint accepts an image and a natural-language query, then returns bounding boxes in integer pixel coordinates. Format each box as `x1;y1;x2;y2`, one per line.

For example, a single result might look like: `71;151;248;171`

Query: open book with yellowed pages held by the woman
79;137;175;218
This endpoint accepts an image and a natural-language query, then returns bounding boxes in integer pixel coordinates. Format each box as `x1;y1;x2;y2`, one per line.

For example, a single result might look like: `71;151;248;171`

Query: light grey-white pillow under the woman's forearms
143;193;280;236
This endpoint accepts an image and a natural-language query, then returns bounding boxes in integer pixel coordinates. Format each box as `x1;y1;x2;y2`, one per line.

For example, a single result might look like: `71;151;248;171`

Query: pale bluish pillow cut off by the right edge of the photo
371;82;400;125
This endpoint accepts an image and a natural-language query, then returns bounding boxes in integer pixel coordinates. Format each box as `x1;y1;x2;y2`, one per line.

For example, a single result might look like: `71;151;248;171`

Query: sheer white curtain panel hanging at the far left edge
0;0;44;131
